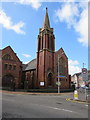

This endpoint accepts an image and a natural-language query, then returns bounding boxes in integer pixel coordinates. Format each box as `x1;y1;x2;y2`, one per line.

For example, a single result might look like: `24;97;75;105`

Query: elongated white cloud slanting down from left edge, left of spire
0;9;25;34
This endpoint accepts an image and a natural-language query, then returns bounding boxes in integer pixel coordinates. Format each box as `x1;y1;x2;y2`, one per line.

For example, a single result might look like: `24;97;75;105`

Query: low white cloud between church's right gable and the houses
68;60;81;75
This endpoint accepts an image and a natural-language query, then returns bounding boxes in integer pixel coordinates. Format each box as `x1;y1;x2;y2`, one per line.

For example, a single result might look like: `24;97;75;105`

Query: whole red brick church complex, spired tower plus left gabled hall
2;8;70;89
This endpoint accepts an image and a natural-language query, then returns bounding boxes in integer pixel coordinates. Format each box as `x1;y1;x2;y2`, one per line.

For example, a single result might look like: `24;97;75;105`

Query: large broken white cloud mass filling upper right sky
55;2;88;46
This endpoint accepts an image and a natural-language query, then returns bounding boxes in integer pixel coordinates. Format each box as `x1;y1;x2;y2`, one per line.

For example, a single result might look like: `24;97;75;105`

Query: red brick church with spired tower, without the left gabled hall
23;8;69;88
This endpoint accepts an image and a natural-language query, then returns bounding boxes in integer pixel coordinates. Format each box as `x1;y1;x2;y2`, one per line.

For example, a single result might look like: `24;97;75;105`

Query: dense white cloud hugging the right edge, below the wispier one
74;9;88;46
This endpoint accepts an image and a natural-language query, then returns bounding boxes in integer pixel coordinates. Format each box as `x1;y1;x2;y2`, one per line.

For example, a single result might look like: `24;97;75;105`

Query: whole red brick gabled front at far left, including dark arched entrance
2;46;22;88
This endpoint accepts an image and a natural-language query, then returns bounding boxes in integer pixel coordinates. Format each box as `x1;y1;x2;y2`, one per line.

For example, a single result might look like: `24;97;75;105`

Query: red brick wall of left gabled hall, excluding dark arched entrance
2;46;22;88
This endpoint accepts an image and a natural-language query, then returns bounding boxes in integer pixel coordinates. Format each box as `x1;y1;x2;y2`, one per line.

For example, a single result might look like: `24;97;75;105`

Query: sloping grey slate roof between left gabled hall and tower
23;59;36;71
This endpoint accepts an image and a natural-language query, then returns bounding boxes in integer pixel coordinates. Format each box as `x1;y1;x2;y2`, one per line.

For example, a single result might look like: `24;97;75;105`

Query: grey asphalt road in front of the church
2;93;88;118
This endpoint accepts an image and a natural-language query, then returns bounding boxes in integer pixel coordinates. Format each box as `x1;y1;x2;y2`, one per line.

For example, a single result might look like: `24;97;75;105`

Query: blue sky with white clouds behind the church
0;0;89;75
